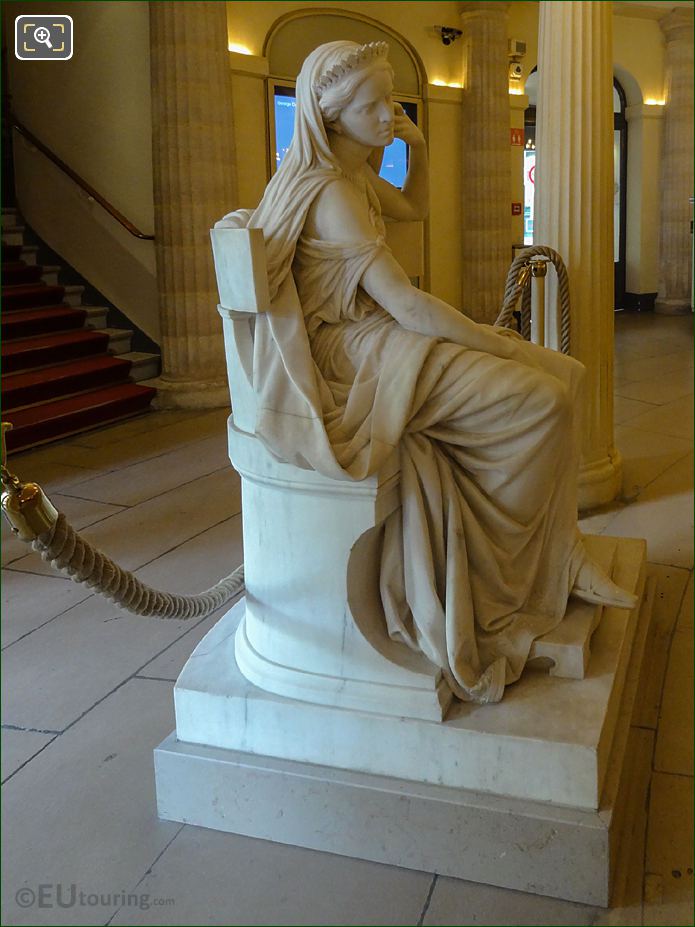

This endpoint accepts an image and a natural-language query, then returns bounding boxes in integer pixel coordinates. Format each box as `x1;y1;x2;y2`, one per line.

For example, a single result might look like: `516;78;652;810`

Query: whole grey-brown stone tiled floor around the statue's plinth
2;315;693;927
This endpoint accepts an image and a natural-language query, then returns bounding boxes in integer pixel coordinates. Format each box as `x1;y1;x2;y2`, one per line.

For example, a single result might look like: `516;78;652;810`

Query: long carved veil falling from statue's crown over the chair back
235;42;394;479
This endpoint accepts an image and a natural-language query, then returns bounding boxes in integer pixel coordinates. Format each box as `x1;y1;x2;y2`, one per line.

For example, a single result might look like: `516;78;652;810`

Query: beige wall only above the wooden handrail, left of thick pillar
3;0;154;232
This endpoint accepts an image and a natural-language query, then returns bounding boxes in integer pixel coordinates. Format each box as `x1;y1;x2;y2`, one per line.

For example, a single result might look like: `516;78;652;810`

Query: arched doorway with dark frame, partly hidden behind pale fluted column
524;68;627;309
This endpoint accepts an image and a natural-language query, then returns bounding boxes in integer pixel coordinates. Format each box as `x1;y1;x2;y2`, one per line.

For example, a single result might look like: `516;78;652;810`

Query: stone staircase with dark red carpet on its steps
2;209;159;451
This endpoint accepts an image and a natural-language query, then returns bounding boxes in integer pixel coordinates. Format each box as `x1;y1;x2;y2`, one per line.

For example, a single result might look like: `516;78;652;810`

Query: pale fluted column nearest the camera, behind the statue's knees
534;0;621;509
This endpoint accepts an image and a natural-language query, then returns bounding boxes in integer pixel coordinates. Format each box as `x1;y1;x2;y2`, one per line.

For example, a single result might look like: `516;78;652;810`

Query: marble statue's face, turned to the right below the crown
330;68;394;148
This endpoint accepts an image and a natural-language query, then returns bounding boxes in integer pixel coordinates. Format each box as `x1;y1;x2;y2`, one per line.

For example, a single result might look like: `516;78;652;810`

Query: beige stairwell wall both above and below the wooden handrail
3;0;159;340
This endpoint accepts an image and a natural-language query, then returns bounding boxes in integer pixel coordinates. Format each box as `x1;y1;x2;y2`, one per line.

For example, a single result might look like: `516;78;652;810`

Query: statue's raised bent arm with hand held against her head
367;103;430;222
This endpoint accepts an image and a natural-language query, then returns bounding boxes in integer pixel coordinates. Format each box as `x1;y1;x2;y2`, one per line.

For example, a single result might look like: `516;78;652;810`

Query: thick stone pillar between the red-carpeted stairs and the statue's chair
150;0;236;409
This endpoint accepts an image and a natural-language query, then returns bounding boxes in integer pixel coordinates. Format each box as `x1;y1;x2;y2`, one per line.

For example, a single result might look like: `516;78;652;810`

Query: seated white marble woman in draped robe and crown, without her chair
218;41;636;702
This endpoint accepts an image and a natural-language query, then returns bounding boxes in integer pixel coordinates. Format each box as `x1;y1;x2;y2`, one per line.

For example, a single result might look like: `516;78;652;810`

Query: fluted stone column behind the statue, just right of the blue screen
461;2;512;322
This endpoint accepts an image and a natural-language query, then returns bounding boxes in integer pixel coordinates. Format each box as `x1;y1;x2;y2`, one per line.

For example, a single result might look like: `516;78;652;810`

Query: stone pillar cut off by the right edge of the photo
655;8;693;315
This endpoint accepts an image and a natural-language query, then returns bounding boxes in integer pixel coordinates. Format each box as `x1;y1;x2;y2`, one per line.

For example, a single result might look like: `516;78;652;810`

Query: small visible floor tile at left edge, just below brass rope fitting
0;568;91;648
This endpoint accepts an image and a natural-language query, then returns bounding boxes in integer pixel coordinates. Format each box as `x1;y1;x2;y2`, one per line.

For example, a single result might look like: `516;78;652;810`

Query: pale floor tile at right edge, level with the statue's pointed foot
604;454;693;569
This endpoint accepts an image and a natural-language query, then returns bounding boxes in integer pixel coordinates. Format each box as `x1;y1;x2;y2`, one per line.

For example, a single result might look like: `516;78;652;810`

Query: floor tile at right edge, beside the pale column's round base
615;425;692;499
